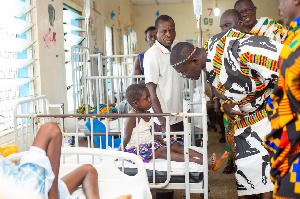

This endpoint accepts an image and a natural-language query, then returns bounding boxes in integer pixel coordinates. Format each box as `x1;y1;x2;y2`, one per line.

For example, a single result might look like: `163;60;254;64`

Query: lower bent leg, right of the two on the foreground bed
62;164;99;199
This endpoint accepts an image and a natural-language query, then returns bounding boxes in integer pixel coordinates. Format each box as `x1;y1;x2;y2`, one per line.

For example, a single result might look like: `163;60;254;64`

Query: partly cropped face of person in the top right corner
278;0;300;26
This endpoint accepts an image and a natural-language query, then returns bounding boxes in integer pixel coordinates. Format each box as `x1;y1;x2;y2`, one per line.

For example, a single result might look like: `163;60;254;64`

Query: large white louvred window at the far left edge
0;0;36;132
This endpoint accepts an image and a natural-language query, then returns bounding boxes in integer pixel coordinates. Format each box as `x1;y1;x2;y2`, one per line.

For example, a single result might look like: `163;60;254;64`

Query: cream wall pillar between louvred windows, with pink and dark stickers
32;0;66;107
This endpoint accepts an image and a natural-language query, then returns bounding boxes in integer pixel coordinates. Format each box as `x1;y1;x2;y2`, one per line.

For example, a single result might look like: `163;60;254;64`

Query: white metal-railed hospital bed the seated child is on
14;97;208;198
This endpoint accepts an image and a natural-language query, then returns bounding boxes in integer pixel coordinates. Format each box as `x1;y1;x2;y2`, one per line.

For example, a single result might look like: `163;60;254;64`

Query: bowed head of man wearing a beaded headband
170;42;206;79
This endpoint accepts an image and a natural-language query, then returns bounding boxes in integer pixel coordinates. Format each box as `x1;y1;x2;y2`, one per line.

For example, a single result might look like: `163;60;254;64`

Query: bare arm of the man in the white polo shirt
146;82;166;132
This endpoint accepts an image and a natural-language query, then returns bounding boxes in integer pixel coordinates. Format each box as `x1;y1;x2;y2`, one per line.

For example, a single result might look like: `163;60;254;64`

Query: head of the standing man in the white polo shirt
155;15;176;50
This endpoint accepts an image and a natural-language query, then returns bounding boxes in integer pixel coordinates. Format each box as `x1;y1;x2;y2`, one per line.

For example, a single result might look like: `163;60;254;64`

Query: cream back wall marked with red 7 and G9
134;0;279;53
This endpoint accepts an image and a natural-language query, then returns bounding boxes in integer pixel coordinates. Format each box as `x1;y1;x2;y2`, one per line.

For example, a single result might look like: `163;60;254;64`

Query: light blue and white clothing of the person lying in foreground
0;146;77;199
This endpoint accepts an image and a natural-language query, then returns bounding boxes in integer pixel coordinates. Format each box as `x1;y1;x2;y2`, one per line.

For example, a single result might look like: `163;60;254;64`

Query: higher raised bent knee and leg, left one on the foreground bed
32;123;62;199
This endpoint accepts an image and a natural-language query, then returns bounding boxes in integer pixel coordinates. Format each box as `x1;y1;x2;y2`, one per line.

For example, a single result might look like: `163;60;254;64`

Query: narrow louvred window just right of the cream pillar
63;4;85;112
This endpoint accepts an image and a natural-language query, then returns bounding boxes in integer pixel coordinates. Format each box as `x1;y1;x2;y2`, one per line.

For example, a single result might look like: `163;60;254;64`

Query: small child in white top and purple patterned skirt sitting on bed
119;84;228;171
